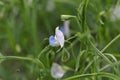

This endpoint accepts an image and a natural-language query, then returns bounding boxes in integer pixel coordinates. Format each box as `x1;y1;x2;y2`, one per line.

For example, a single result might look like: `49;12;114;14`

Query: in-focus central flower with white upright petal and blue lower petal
49;27;64;48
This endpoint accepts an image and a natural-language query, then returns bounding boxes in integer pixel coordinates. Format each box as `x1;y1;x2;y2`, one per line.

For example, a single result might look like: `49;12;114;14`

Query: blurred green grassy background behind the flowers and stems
0;0;120;80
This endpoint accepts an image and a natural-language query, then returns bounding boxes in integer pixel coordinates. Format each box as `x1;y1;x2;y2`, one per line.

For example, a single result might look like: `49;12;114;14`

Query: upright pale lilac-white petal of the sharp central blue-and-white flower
55;27;64;48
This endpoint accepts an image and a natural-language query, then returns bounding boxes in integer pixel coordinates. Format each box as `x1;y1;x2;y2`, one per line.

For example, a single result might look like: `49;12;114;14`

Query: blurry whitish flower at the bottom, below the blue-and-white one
51;63;65;79
